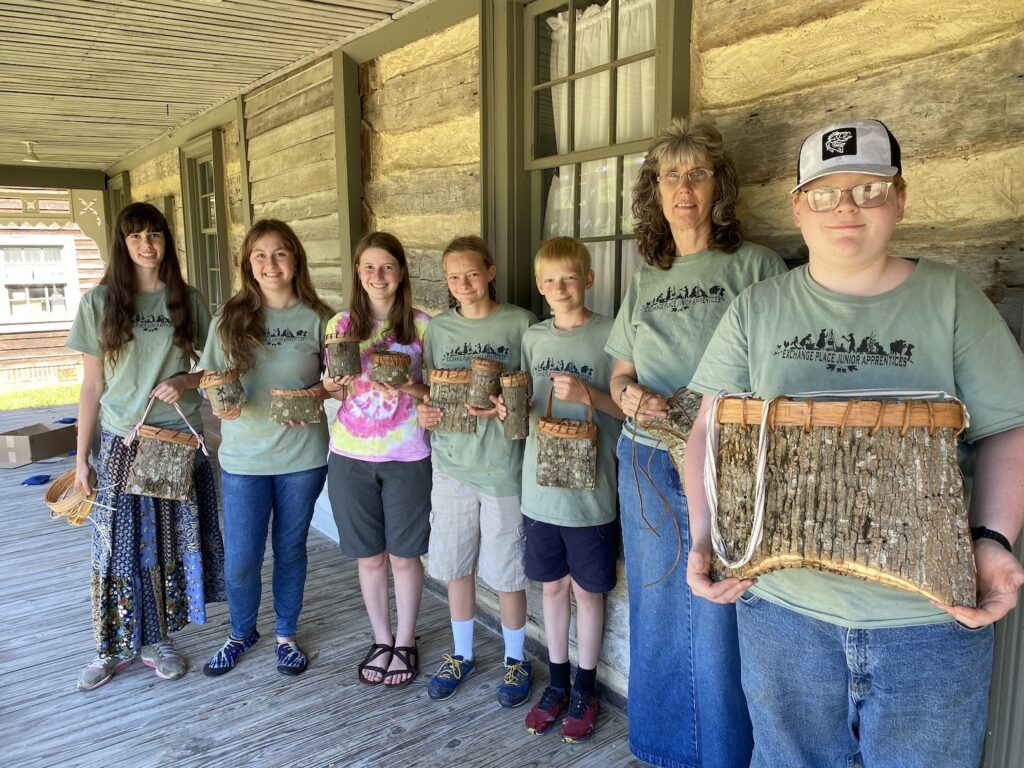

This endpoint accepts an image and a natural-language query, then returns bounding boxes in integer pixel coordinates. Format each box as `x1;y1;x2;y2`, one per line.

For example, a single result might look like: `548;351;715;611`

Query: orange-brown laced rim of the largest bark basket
716;397;967;433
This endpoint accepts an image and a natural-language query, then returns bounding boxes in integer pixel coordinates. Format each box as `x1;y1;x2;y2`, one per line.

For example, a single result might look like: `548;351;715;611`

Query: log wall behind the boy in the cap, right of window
690;0;1024;339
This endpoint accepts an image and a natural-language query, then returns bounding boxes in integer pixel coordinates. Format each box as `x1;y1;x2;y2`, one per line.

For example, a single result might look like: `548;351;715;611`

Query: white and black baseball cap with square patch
790;120;903;195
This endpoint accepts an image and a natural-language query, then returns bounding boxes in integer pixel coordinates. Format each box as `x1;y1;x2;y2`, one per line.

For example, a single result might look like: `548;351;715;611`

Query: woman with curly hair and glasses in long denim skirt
605;118;785;767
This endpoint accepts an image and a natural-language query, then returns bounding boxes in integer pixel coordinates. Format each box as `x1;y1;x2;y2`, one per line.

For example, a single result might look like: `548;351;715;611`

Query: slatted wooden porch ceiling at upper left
0;0;419;170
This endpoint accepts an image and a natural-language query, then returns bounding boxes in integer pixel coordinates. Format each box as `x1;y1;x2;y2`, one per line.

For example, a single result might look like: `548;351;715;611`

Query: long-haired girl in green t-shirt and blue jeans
200;219;332;677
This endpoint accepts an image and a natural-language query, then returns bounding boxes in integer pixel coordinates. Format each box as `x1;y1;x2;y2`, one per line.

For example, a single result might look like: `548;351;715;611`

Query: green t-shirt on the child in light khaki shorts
423;304;537;497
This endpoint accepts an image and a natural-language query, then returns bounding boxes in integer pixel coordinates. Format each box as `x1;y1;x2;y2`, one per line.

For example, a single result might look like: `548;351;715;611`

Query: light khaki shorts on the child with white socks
427;469;528;592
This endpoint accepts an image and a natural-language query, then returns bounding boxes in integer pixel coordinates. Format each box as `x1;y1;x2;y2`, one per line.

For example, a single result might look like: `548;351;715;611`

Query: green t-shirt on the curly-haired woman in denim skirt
604;243;785;449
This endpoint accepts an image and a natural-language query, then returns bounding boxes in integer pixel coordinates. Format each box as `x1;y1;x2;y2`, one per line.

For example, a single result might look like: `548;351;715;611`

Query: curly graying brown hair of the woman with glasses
633;118;743;269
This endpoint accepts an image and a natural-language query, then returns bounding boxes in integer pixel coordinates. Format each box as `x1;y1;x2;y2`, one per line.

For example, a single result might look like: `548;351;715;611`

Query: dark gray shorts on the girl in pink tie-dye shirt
327;453;431;557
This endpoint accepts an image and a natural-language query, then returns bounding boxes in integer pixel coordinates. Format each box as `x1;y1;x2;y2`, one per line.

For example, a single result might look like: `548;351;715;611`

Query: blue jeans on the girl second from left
220;466;327;638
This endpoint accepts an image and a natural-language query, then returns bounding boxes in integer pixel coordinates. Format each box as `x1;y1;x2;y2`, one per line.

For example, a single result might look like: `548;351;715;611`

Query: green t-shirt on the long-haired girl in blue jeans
199;302;328;475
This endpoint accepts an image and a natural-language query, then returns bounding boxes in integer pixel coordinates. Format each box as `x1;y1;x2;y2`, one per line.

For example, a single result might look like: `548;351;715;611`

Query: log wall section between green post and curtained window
359;16;480;314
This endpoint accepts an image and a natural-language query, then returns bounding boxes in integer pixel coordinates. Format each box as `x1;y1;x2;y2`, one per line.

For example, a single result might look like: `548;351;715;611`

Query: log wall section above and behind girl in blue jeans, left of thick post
245;58;350;307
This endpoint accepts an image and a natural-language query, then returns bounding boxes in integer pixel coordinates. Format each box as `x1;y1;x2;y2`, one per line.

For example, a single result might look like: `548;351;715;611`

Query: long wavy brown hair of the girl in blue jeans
217;219;334;373
